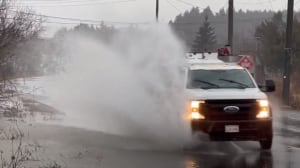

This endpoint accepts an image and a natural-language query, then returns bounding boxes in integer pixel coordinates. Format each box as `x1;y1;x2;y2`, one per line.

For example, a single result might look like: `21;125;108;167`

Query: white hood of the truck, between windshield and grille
187;88;267;100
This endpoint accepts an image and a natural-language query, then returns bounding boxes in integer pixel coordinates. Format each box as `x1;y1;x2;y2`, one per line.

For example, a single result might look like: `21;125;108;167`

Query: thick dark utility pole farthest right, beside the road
282;0;294;105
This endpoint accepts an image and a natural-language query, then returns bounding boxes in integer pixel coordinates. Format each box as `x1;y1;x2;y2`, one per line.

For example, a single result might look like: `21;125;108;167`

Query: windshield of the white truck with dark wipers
187;69;255;89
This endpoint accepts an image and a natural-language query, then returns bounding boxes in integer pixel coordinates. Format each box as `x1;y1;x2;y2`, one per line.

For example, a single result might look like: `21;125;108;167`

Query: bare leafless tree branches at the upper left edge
0;0;42;80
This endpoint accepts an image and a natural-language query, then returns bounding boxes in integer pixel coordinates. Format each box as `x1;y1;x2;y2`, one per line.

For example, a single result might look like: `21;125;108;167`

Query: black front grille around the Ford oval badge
201;99;259;121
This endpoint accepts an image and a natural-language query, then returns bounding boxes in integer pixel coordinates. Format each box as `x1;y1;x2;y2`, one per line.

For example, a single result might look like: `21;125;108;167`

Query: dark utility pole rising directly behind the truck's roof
228;0;234;53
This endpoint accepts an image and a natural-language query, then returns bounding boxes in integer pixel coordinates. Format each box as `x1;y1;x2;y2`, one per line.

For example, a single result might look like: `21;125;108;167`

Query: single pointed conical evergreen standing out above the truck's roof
192;16;217;52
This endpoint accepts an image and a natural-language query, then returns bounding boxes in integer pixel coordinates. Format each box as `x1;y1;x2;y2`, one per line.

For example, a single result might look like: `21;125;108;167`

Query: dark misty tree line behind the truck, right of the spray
170;7;300;73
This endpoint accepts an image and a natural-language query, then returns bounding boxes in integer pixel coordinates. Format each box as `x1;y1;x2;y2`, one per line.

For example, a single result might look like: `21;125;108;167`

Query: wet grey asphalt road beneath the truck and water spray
26;106;300;168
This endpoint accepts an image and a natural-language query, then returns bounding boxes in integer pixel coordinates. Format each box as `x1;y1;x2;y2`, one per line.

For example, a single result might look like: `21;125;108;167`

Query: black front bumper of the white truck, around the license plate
191;119;273;141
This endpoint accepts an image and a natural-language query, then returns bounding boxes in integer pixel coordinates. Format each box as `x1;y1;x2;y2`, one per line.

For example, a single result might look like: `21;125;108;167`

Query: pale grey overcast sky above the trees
16;0;300;35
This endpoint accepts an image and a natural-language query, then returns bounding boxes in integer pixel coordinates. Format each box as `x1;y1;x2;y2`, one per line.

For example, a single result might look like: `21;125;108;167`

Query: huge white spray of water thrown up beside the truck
44;25;190;148
